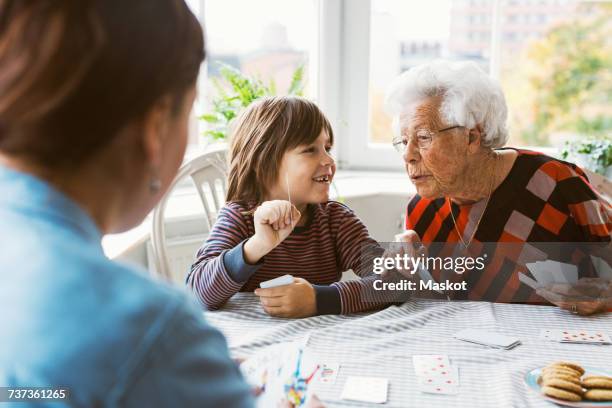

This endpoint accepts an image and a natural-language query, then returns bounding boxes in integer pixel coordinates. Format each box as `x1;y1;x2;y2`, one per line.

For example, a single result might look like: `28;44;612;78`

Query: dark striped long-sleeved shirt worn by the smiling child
187;201;382;314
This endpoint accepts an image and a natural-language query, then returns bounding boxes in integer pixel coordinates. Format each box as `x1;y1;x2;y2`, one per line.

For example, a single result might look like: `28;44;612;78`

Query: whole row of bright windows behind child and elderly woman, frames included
188;0;612;169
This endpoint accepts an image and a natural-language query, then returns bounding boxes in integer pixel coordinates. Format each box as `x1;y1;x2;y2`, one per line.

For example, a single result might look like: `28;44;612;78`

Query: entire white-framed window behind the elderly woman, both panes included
339;0;612;169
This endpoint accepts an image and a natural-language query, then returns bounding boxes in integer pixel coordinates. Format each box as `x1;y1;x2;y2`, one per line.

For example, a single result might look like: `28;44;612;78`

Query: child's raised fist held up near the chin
244;200;301;264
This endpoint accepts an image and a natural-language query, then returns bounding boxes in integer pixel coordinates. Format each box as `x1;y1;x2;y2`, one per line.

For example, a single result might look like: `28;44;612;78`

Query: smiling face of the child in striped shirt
267;131;336;206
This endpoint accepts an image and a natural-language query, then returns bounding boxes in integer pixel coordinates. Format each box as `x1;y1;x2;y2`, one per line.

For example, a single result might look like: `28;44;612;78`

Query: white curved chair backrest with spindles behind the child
151;146;227;280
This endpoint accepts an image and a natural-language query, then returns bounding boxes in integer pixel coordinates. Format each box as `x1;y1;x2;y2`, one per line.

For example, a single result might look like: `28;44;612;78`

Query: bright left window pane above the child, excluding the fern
200;0;318;143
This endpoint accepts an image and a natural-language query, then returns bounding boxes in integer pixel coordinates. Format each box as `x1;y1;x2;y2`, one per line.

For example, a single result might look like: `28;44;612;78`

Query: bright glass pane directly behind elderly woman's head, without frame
369;0;492;143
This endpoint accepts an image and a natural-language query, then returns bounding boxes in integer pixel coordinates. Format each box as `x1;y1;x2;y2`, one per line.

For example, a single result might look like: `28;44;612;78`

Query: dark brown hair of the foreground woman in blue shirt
0;0;204;169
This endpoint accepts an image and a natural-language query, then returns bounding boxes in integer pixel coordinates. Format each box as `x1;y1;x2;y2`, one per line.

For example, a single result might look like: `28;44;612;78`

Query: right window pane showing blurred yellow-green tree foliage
500;0;612;147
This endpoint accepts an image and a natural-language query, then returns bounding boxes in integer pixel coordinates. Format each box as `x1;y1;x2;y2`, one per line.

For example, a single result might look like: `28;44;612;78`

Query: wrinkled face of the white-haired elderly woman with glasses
399;98;469;199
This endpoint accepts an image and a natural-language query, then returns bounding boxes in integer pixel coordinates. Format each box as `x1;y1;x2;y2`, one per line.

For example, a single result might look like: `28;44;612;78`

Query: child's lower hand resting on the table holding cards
255;278;317;318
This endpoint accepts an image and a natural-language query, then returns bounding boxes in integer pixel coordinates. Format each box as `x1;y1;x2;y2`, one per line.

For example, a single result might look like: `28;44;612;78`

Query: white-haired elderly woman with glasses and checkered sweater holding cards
387;61;612;313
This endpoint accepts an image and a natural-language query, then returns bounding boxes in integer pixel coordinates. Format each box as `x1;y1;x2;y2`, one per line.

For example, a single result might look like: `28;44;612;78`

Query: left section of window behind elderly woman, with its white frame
339;0;491;169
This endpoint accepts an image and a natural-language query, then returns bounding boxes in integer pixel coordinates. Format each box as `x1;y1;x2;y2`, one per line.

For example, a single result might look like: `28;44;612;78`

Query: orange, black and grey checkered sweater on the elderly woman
406;149;612;303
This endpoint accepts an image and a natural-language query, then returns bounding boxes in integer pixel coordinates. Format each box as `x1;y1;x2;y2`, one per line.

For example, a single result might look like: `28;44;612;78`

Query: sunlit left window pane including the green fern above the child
193;0;318;144
